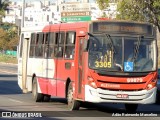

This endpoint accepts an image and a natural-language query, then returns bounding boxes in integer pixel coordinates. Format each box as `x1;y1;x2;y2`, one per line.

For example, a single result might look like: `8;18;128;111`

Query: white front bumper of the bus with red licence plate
85;85;157;104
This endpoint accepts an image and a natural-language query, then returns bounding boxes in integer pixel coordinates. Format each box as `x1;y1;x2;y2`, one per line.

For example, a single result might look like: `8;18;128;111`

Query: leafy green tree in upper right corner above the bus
117;0;160;31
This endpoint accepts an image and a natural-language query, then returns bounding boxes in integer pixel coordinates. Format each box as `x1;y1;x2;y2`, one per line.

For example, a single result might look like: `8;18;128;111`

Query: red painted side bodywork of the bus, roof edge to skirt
38;22;89;99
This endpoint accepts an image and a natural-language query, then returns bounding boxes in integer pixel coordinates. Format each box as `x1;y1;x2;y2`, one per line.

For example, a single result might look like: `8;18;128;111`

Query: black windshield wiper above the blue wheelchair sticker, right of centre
133;36;144;62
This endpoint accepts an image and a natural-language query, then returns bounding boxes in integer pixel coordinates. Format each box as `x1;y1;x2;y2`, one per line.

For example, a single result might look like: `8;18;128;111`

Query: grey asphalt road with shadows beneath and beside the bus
0;64;160;120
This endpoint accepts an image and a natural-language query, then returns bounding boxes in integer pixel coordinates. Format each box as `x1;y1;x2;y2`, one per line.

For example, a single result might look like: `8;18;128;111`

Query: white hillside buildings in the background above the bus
3;0;117;26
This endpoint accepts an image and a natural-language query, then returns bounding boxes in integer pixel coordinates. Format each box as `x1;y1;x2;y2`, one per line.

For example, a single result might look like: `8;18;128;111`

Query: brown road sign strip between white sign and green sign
61;11;91;17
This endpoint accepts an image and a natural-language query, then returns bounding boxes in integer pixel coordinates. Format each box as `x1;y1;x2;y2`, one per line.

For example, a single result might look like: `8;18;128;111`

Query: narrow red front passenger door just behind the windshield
77;37;85;99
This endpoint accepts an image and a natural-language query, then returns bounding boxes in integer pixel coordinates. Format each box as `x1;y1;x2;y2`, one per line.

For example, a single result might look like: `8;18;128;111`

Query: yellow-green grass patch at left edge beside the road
0;54;18;64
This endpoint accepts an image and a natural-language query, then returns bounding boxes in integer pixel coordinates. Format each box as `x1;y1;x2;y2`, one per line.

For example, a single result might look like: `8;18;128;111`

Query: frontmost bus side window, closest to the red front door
64;32;76;59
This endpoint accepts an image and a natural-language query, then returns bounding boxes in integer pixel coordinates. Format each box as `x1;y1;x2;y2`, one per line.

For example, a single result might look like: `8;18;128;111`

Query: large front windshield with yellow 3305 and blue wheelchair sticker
89;34;156;72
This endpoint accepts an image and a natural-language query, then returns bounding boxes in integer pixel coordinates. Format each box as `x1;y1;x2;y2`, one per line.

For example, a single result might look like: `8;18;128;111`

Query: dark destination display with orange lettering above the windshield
92;21;153;35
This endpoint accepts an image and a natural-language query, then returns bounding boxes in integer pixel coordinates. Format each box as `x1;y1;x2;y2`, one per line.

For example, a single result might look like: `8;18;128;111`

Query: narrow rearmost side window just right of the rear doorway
29;33;36;57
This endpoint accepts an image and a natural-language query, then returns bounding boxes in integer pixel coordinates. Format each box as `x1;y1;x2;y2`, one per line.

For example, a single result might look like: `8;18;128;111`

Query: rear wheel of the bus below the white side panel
32;77;44;102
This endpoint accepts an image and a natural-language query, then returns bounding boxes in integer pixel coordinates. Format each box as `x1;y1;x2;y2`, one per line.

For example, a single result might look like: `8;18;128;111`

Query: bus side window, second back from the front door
54;32;65;58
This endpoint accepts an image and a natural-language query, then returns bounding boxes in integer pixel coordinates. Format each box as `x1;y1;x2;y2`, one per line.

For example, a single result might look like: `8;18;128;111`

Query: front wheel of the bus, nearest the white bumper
67;82;80;110
